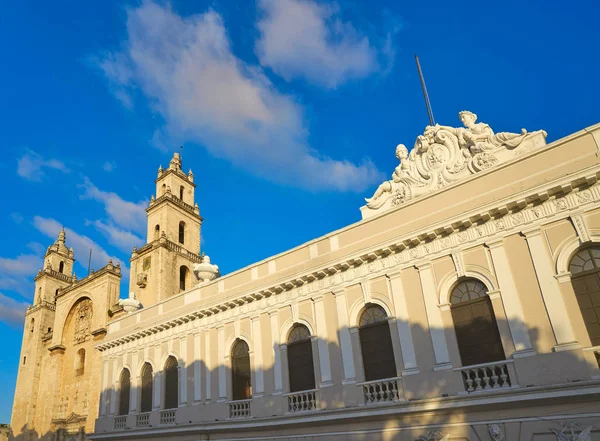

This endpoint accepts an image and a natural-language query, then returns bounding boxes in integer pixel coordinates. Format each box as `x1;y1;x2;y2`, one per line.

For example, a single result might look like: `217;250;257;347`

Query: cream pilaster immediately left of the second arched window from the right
417;263;452;371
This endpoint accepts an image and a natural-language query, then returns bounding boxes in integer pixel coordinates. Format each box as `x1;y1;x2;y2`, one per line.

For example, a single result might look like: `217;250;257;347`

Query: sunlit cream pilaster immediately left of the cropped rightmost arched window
523;227;579;351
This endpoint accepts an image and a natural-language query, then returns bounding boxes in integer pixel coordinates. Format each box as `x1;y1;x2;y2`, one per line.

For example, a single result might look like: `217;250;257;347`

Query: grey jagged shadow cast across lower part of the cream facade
9;318;600;441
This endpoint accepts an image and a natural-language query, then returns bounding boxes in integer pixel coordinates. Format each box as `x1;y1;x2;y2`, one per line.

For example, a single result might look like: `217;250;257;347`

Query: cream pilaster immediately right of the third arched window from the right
388;271;419;375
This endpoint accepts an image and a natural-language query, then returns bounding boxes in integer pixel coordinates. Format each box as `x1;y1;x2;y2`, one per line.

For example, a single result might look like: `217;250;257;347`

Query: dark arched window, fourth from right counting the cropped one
287;325;315;392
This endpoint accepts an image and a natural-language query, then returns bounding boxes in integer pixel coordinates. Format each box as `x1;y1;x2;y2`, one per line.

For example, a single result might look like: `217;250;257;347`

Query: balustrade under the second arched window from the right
454;360;516;393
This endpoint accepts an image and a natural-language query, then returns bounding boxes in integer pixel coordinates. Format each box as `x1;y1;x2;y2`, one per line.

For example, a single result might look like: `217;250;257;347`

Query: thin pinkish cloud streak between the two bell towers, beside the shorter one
33;216;127;273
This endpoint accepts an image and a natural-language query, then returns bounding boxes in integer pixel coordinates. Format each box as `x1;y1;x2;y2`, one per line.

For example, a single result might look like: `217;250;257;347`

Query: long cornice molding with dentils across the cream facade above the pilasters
96;170;600;351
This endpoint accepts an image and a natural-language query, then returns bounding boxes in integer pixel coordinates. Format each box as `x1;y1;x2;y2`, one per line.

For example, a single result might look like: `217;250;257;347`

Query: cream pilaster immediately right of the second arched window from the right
486;239;535;357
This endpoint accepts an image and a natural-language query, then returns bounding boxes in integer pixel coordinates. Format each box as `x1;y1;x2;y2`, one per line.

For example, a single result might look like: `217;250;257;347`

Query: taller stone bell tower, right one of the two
129;153;202;307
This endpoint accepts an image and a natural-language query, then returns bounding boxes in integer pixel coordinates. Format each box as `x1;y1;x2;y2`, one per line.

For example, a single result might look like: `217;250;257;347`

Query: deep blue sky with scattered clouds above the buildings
0;0;600;422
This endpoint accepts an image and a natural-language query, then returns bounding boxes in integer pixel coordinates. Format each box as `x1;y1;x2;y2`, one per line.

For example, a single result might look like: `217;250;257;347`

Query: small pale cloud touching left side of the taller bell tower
81;178;148;234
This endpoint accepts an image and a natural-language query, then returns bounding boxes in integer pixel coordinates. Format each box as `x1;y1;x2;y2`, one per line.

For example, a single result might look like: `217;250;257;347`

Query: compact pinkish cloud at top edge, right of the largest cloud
256;0;393;88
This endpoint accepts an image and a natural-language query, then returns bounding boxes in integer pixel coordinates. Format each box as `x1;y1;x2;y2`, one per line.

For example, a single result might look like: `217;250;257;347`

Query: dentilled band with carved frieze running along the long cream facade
97;172;600;351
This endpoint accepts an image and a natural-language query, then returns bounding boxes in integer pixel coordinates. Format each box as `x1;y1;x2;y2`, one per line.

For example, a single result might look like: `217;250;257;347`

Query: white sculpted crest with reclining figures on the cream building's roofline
361;111;546;218
